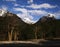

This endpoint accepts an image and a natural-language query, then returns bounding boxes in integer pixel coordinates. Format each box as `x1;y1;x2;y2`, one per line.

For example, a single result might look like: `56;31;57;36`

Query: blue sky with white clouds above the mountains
0;0;60;23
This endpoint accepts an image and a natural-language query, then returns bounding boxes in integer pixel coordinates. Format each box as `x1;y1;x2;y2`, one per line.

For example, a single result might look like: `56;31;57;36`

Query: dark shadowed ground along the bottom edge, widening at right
0;40;60;47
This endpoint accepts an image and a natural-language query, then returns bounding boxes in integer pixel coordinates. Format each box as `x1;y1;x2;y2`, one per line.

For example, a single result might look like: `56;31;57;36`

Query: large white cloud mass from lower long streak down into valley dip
13;8;47;23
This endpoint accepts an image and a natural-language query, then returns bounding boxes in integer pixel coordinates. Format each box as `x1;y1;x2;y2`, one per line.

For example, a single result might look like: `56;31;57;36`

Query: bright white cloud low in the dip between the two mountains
17;13;36;24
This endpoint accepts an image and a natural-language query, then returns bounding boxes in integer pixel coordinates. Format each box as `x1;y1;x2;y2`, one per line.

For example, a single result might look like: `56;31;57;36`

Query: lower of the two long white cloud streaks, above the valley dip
14;8;48;15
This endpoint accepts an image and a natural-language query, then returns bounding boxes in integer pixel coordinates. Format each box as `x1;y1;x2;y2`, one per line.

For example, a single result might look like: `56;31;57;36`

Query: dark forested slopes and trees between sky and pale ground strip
0;12;60;41
